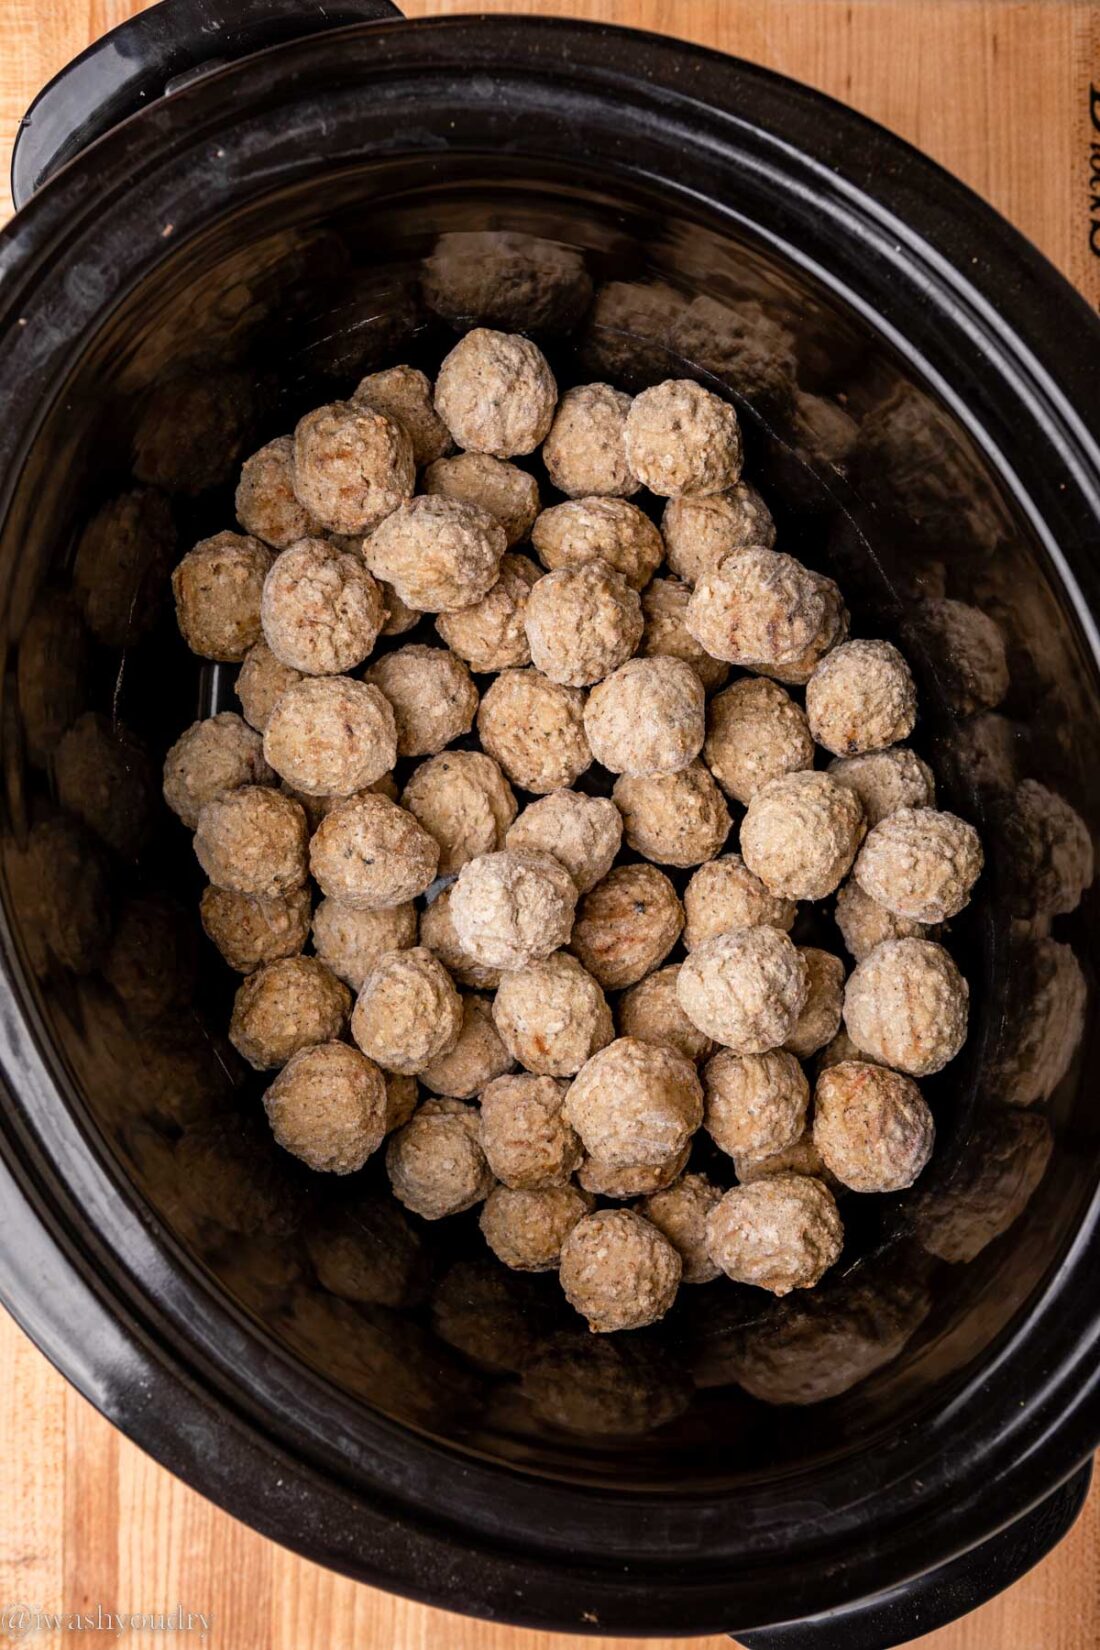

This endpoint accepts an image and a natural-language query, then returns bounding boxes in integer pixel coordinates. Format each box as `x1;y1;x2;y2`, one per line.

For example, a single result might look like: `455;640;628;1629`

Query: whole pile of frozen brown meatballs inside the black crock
163;328;981;1332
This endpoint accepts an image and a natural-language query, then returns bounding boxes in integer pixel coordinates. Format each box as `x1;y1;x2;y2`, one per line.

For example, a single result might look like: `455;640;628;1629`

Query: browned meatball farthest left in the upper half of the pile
172;533;274;663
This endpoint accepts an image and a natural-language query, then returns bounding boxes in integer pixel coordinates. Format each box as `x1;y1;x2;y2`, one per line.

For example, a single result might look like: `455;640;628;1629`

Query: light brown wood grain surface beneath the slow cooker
0;0;1100;1650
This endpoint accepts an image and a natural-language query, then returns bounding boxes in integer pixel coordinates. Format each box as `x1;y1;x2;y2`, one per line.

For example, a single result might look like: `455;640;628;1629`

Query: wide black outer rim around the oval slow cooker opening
0;20;1100;1634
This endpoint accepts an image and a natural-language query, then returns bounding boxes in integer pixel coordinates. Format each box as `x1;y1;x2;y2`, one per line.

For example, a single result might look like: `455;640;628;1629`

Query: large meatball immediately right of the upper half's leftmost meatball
261;538;386;677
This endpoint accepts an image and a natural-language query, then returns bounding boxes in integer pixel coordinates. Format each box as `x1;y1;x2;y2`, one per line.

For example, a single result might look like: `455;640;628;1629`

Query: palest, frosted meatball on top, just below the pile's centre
450;848;577;969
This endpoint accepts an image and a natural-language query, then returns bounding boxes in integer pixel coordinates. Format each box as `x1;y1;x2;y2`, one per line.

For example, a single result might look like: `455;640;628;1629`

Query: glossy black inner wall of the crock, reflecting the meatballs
0;162;1100;1483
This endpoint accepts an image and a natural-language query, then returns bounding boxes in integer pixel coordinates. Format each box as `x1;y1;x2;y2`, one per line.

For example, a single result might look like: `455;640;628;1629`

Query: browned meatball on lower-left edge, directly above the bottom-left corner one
229;957;351;1071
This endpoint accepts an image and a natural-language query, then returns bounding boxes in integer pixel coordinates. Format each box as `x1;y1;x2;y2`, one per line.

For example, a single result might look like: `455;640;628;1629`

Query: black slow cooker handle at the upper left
12;0;402;208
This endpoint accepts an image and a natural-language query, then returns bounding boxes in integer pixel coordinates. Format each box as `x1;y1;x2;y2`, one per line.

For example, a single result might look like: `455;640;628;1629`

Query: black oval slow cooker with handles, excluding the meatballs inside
0;0;1100;1650
